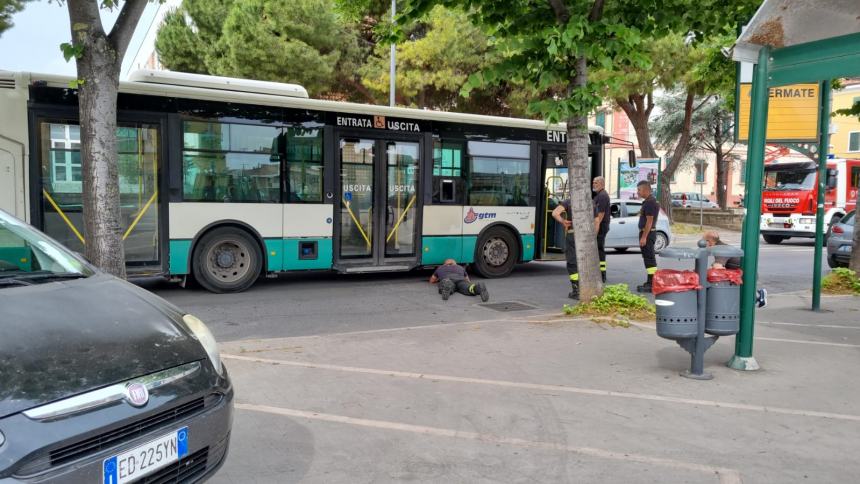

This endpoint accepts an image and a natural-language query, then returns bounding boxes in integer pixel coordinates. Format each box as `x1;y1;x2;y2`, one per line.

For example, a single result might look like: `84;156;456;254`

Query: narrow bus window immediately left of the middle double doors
282;128;323;203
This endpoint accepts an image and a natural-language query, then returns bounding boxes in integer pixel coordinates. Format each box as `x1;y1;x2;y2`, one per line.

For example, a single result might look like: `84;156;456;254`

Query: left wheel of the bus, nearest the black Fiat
192;227;263;294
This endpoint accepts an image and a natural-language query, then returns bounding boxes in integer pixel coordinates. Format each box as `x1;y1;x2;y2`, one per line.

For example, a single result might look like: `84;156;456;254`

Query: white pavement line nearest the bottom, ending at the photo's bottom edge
239;403;743;484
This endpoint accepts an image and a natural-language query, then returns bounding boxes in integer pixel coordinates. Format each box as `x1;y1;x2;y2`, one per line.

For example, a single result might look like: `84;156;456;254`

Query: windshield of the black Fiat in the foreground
0;211;93;288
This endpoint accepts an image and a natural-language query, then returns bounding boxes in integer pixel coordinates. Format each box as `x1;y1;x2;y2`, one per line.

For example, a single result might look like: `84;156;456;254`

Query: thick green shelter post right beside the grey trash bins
728;47;770;370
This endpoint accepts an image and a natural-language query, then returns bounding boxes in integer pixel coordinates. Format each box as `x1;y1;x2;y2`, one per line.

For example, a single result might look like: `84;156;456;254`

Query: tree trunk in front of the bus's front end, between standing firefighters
567;57;603;301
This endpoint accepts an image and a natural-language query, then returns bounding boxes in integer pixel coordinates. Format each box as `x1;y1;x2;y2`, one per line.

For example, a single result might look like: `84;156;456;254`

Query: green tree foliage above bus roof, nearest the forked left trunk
156;0;361;97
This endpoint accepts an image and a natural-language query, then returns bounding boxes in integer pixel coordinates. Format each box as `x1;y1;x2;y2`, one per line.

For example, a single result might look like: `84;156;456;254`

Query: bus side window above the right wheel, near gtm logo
468;141;529;207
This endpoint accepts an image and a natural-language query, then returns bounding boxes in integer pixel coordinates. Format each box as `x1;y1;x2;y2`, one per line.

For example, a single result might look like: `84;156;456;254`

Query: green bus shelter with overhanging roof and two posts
729;0;860;370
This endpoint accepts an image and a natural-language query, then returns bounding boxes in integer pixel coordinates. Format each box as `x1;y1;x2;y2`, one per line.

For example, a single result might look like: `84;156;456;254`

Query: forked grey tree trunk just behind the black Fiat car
67;0;146;278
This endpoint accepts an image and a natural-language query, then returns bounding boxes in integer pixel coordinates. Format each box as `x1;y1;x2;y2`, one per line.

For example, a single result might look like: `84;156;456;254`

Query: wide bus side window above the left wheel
182;121;281;203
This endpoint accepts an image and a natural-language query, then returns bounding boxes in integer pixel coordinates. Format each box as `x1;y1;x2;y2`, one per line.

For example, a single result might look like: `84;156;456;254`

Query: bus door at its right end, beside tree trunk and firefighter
537;149;570;260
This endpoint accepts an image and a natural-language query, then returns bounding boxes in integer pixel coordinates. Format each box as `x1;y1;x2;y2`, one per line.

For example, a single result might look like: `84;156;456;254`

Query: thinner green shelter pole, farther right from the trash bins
812;80;830;311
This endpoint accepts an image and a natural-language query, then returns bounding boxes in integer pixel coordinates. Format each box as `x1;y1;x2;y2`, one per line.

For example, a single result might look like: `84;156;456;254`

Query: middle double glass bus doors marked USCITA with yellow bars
334;135;422;272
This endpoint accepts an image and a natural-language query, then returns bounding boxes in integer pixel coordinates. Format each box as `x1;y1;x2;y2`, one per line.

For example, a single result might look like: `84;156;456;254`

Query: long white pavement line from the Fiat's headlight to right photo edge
221;354;860;422
